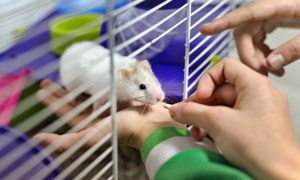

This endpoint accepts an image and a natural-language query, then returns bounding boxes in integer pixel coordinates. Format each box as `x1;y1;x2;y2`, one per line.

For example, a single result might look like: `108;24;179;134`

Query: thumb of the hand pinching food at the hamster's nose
169;102;228;135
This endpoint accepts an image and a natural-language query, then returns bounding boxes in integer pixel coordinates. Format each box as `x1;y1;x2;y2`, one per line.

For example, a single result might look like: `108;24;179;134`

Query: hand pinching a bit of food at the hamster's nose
170;59;300;179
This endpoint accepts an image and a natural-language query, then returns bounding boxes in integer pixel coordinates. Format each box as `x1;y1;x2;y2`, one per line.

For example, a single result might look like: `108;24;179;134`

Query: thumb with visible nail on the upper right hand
267;36;300;70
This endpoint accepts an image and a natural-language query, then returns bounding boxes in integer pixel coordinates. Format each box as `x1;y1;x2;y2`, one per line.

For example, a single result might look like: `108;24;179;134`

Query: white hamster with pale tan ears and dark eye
59;41;165;110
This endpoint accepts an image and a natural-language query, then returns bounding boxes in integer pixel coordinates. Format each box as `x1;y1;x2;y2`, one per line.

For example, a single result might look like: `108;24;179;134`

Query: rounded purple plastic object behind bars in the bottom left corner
0;125;62;180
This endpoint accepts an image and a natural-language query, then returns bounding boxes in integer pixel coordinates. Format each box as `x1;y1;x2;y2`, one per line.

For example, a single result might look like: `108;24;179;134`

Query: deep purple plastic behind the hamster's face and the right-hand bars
151;3;229;100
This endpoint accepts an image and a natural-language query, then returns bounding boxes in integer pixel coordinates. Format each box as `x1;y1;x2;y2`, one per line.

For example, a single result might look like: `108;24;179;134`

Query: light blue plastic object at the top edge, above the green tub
58;0;130;13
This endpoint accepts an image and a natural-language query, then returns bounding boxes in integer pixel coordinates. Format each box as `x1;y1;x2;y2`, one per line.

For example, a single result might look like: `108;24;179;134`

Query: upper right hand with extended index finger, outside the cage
200;0;300;76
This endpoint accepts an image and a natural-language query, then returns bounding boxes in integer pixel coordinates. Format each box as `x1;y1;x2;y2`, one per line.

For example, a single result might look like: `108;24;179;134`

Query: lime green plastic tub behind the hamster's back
50;14;103;55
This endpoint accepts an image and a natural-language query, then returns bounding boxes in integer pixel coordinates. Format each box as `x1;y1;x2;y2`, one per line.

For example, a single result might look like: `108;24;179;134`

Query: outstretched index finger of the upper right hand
200;0;295;35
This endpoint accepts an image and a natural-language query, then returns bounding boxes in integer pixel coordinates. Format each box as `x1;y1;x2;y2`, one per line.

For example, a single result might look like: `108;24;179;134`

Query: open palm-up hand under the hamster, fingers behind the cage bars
34;80;184;153
